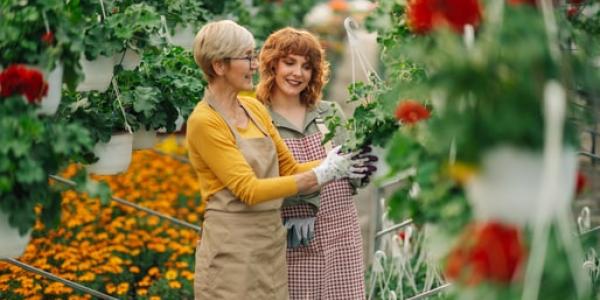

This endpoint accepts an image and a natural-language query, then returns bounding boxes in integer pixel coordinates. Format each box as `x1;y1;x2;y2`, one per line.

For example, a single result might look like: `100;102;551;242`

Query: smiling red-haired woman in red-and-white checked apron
257;28;376;300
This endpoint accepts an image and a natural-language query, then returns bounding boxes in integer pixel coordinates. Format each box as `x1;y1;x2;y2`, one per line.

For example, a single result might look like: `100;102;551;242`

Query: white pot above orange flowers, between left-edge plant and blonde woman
87;133;133;175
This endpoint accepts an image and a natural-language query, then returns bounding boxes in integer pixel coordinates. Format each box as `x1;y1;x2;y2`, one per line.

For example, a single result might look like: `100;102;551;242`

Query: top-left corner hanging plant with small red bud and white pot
0;1;83;115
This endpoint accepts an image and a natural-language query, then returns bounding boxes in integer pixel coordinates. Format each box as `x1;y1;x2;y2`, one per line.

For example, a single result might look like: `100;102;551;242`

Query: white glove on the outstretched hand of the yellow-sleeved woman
313;146;366;185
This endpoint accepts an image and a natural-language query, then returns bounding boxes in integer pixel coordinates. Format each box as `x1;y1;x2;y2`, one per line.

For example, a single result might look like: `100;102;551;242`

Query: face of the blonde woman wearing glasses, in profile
223;48;258;91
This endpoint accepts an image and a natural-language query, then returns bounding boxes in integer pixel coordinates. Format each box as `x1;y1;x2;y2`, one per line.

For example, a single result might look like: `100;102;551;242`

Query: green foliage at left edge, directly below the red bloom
0;95;106;234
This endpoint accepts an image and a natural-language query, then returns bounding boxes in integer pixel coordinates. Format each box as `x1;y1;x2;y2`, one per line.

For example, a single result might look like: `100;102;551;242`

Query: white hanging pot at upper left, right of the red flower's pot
77;55;114;92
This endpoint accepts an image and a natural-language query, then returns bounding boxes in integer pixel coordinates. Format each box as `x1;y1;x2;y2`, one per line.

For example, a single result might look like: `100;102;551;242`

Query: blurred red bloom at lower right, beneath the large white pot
445;222;527;285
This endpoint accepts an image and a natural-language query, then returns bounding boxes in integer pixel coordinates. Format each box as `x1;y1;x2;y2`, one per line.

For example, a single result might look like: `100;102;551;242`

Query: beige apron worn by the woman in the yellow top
194;100;288;300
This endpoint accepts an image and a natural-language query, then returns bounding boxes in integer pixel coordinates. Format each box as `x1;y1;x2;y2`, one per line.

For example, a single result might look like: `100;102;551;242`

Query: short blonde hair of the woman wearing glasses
194;20;256;82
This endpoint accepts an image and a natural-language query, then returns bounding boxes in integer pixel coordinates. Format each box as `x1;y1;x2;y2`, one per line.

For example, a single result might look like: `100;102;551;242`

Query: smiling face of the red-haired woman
273;54;313;97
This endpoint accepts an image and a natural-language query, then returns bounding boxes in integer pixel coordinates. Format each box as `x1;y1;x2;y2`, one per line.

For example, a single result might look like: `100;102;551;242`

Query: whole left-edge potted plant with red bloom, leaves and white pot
0;65;93;258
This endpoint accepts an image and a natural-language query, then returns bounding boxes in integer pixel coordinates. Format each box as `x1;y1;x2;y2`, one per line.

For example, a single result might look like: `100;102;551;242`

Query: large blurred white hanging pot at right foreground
466;146;577;226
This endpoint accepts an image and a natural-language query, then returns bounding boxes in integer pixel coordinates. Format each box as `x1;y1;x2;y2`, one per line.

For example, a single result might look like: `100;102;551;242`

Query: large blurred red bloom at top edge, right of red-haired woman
406;0;482;34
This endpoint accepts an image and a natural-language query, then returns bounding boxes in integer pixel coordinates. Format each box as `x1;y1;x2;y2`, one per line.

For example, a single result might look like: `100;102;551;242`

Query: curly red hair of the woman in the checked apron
256;27;329;106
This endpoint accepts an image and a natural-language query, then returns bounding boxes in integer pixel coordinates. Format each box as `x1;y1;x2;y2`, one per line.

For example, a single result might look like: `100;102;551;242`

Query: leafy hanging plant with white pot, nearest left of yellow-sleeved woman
59;91;133;175
